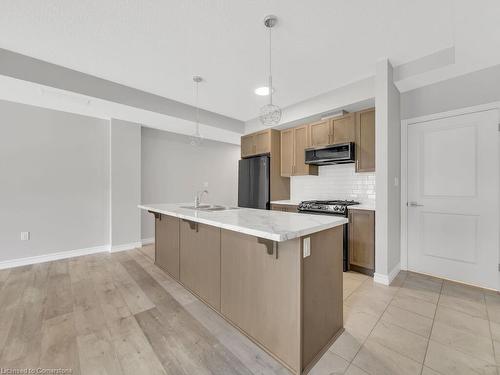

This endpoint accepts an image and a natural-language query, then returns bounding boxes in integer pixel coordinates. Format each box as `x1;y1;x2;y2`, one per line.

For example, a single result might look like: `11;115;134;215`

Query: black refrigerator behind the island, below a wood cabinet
238;156;270;210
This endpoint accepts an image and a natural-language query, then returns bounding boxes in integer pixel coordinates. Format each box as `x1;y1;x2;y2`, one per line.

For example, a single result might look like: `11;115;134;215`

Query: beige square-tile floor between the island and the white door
143;248;500;375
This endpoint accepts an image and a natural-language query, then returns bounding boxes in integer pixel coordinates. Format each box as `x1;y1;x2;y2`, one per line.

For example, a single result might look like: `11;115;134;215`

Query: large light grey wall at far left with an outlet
0;101;109;261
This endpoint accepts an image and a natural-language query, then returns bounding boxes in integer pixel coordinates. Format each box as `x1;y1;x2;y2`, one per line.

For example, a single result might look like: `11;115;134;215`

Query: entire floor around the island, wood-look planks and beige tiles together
0;246;500;375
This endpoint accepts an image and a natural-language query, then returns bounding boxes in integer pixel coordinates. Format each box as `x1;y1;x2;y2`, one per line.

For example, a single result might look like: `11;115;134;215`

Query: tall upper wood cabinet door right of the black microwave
356;109;375;172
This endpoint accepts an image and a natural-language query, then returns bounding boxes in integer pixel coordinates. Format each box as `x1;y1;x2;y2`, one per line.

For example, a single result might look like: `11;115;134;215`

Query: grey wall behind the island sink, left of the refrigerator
141;127;240;239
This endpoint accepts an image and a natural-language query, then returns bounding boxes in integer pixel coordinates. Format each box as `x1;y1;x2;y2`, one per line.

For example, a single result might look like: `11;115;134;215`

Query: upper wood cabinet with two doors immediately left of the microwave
281;125;318;177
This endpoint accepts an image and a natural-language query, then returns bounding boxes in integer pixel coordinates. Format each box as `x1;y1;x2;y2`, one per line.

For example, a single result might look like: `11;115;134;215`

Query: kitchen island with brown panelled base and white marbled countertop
139;204;347;374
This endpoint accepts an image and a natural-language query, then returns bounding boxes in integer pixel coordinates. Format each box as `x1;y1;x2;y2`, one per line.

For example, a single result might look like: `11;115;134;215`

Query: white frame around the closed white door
400;102;500;271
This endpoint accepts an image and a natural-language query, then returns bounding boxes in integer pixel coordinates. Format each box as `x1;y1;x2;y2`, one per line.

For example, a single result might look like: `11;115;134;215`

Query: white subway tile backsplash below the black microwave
290;164;375;203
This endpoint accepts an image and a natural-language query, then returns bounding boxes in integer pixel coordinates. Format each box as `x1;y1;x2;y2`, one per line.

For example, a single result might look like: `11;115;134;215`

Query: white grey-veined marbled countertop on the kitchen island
138;203;347;242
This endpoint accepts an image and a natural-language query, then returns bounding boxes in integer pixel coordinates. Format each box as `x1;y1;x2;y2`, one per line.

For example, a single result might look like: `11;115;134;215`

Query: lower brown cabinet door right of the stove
349;210;375;273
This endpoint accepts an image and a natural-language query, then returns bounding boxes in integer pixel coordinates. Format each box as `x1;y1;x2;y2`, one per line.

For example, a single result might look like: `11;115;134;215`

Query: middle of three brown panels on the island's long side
180;220;220;310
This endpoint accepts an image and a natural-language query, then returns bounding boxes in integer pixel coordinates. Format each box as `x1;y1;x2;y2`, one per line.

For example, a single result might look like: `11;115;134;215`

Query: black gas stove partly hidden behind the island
298;200;359;272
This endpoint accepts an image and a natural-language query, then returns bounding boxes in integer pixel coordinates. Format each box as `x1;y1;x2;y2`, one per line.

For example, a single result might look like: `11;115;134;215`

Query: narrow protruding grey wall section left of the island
109;119;141;250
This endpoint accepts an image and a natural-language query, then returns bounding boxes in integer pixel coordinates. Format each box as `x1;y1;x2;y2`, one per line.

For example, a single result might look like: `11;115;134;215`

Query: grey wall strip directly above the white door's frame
401;65;500;119
